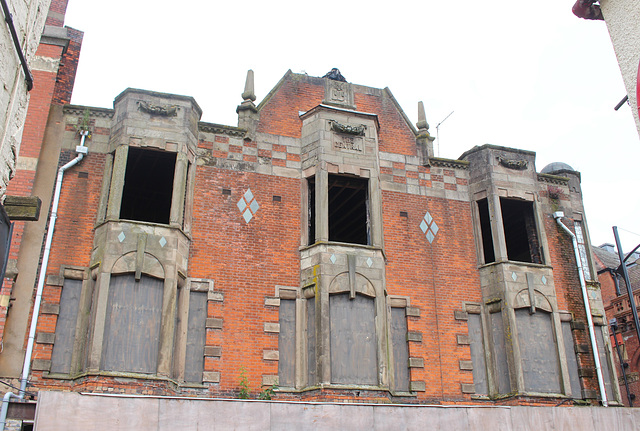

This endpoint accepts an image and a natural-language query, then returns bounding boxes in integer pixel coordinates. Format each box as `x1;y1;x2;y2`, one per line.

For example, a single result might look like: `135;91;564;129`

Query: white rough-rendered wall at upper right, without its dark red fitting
600;0;640;139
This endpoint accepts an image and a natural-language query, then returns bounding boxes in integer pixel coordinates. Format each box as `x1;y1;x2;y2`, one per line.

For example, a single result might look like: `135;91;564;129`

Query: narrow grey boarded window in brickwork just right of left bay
184;291;207;383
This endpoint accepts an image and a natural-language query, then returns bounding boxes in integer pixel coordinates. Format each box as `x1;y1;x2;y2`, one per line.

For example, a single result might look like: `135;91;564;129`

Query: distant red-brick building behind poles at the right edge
593;244;640;406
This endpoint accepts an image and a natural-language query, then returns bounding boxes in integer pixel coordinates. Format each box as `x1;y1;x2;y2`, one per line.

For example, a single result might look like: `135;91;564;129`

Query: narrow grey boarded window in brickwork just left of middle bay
278;298;296;387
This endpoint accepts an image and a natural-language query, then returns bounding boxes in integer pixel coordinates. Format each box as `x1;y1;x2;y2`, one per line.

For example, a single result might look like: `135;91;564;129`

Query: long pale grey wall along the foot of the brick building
36;392;640;431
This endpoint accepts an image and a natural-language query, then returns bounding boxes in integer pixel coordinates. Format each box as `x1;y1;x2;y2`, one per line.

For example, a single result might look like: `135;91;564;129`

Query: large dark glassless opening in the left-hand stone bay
120;147;176;224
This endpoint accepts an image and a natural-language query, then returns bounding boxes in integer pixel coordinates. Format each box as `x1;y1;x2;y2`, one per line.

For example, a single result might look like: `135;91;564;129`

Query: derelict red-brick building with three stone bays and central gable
0;69;640;429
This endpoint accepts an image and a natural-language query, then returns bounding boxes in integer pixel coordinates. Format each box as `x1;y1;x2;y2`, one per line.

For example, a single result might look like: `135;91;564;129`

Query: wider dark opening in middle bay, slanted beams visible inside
329;175;370;245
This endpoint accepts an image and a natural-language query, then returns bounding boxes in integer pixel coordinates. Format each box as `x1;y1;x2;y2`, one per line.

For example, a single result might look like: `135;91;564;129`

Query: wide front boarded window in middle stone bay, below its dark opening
329;293;378;385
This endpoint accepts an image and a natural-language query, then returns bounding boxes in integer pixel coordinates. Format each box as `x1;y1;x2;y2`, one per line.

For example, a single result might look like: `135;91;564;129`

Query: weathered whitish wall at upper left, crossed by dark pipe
0;0;51;197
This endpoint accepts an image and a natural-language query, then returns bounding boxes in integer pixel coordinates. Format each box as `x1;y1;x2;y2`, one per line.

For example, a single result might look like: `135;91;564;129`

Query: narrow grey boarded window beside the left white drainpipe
51;279;82;374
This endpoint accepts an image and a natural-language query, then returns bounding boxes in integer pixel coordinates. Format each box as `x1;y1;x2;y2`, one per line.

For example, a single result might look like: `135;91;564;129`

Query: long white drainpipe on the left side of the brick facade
0;130;89;431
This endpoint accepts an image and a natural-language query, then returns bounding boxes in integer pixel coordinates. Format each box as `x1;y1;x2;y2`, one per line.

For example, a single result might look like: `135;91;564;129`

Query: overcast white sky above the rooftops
66;0;640;250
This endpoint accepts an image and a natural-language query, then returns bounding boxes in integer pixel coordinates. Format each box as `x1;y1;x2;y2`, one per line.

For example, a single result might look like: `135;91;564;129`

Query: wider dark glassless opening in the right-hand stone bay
500;198;542;263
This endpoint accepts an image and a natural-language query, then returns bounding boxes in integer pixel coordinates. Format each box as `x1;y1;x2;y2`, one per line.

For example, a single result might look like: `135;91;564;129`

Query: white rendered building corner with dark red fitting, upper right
573;0;640;138
